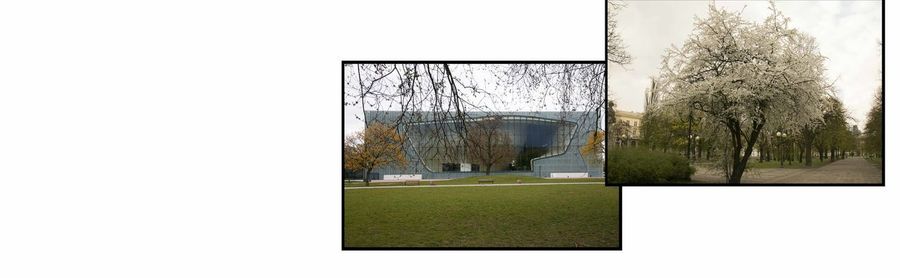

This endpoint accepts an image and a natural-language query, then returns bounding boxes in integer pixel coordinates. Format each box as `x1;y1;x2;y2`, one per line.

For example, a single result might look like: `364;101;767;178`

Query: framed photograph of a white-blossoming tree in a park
605;0;885;186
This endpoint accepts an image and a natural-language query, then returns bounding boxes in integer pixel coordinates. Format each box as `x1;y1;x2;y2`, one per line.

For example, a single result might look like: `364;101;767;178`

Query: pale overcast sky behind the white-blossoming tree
609;1;882;128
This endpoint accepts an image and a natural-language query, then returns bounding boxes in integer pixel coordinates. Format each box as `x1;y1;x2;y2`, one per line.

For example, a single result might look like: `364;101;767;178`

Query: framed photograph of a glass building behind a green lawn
341;61;622;250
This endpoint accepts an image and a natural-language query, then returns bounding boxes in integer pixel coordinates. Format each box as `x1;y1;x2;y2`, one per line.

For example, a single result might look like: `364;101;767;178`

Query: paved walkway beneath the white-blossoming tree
691;157;882;183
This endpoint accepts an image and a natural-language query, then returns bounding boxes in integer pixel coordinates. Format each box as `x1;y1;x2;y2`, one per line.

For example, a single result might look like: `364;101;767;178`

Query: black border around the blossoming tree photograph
603;0;887;187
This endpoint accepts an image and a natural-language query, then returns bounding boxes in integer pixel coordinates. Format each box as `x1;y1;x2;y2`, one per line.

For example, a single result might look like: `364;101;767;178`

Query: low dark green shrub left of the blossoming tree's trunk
606;147;694;183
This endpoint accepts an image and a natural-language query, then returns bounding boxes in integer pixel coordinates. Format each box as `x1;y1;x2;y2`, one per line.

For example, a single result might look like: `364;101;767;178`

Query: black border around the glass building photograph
339;60;623;251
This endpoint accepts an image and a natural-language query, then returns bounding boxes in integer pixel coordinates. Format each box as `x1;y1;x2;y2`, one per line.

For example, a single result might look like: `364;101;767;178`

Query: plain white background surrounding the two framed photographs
0;0;900;277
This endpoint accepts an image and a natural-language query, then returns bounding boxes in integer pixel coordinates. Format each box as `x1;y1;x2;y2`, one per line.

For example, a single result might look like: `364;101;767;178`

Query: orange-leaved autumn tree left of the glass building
344;122;406;186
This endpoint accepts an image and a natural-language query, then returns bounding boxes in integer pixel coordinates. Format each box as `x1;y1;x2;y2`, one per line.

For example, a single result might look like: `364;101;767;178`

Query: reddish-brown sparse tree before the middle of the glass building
465;118;516;175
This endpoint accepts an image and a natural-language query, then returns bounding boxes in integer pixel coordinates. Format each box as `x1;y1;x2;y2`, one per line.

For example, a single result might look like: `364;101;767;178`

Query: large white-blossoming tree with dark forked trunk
661;4;828;183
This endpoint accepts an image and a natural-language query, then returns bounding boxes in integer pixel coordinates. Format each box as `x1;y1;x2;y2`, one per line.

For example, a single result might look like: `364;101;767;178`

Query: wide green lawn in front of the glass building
344;185;621;248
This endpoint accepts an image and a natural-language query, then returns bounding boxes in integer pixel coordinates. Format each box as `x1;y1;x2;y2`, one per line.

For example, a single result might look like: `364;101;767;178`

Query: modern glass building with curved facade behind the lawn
365;111;603;179
